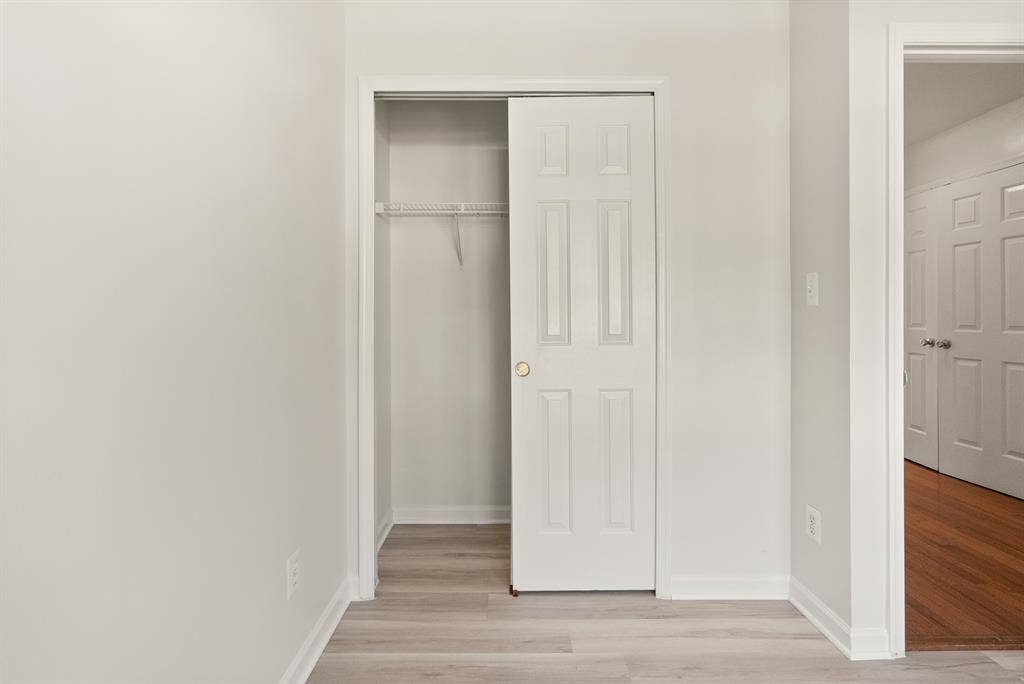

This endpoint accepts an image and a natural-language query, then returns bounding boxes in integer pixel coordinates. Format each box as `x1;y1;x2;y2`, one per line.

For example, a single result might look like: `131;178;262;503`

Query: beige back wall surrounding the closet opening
345;2;790;589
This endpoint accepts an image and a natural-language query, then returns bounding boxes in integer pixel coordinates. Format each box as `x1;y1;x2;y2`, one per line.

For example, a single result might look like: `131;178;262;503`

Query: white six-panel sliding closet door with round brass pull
509;96;655;591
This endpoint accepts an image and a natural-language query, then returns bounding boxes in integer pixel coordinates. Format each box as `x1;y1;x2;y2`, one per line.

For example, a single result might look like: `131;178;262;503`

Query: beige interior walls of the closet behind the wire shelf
375;100;511;532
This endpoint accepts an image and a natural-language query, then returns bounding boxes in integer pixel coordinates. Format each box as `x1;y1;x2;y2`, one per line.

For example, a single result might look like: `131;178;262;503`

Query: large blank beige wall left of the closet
0;3;346;682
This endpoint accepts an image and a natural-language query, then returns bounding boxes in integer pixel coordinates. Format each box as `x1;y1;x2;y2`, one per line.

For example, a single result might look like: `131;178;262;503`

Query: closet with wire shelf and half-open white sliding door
373;95;656;591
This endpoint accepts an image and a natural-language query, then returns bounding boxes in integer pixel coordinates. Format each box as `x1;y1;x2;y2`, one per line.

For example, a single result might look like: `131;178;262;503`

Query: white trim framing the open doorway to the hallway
884;24;1024;658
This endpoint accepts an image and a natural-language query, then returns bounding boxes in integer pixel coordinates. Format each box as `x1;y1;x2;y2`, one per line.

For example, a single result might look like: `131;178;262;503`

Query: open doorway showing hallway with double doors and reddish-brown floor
903;61;1024;651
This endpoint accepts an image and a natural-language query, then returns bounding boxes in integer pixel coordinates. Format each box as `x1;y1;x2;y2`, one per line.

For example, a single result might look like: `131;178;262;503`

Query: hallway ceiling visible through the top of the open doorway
903;63;1024;144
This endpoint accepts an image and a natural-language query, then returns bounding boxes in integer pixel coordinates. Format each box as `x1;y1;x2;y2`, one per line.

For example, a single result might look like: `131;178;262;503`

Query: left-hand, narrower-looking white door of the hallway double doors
903;190;939;470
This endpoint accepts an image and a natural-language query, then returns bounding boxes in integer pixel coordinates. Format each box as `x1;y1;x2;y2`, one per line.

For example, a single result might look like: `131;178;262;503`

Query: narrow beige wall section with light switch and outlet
790;0;850;622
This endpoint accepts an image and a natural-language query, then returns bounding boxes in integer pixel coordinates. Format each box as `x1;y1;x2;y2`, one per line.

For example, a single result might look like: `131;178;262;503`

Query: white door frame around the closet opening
345;76;671;600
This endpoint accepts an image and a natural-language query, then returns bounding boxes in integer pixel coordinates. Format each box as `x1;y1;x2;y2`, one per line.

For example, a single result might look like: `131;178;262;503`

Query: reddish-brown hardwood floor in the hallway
904;461;1024;650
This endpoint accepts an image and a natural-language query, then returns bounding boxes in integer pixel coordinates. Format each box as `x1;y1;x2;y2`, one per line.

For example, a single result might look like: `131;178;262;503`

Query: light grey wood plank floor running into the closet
309;525;1024;684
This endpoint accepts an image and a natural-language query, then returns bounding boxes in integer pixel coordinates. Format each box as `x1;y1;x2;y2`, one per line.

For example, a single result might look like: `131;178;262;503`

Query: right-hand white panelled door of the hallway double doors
937;165;1024;498
